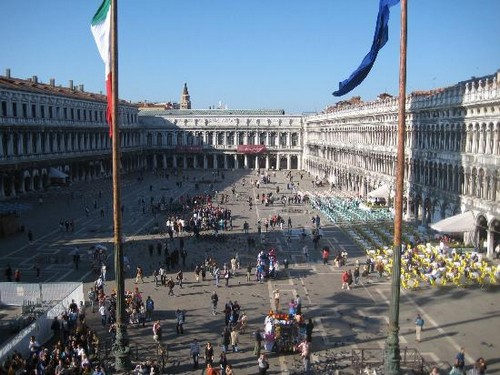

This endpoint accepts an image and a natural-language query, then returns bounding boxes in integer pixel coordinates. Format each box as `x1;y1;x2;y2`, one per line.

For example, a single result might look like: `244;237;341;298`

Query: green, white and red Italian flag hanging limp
90;0;113;137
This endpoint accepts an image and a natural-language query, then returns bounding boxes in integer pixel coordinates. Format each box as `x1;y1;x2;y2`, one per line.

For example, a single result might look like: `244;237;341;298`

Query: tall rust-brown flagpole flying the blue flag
384;0;407;375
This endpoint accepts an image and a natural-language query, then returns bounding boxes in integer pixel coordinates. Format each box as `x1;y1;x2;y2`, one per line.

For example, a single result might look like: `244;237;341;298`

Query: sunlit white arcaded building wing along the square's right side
303;73;500;253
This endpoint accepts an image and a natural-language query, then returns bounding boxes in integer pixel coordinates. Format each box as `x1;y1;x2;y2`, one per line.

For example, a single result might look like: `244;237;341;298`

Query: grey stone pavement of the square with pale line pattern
0;171;500;374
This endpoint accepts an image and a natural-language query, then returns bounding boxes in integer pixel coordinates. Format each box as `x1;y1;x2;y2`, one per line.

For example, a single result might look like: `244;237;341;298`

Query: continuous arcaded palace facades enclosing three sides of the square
0;69;500;251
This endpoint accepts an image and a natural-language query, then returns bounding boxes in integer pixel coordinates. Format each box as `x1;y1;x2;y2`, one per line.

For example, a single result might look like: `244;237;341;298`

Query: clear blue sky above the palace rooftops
0;0;500;114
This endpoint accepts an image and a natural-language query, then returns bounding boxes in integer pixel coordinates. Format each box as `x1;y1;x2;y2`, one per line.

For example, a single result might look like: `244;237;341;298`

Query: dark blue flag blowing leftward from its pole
333;0;399;96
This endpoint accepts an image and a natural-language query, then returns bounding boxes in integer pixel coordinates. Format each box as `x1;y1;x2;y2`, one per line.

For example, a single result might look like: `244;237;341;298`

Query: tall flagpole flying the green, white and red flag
111;0;131;372
